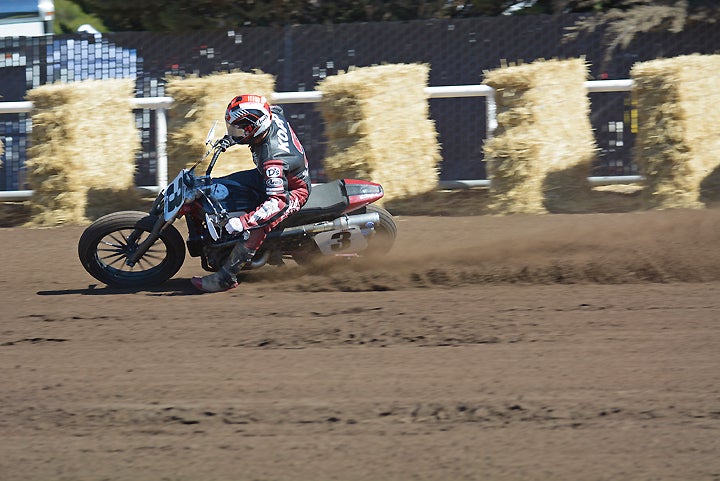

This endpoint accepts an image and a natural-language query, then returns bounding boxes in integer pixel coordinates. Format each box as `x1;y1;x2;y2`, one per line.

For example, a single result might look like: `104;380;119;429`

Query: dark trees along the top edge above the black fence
58;0;720;47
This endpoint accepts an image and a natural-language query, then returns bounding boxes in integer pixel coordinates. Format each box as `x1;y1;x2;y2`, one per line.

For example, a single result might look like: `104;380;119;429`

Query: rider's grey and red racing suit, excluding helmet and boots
227;106;311;251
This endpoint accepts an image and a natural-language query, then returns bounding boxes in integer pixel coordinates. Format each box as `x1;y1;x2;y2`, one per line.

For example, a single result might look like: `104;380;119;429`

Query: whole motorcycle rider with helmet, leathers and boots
191;94;311;292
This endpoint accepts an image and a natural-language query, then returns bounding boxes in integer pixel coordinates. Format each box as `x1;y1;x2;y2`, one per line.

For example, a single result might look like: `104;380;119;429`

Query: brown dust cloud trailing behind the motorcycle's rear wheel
245;209;720;292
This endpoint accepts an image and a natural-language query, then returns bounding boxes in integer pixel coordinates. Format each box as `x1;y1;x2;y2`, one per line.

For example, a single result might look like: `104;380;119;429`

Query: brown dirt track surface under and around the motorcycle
0;210;720;481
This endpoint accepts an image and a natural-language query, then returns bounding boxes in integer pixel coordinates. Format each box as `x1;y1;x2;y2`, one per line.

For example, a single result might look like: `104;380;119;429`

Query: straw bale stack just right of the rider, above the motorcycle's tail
317;64;441;201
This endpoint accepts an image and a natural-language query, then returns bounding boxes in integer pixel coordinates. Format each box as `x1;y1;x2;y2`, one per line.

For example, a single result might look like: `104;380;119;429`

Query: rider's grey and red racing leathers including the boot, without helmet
193;106;311;292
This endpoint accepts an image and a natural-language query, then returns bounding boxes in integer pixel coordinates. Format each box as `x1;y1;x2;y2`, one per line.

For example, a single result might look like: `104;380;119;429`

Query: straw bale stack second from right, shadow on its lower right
484;59;597;214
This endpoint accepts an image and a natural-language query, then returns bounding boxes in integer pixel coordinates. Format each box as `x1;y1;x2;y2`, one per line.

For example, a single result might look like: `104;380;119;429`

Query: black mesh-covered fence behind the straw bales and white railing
0;15;720;190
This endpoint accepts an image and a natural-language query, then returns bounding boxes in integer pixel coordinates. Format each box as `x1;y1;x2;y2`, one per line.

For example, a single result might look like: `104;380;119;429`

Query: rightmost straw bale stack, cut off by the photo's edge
631;55;720;208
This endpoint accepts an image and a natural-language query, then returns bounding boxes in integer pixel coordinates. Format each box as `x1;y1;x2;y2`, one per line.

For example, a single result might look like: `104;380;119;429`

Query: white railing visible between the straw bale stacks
0;79;642;201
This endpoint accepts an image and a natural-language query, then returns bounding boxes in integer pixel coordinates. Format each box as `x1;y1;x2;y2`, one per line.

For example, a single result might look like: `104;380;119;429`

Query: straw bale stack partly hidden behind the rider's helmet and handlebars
166;71;275;177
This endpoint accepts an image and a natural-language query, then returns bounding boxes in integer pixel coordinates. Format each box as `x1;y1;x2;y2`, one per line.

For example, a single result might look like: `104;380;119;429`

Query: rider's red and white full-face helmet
225;94;272;144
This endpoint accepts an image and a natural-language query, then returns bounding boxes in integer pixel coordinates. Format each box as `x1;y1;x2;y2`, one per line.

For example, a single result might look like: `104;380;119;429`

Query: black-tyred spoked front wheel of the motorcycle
78;211;185;288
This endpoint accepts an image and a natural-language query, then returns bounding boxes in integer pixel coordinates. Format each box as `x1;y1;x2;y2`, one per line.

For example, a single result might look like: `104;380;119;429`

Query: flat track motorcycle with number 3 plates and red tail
78;126;397;288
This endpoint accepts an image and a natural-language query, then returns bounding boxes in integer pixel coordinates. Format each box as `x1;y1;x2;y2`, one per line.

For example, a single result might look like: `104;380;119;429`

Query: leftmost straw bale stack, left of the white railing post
26;79;140;226
